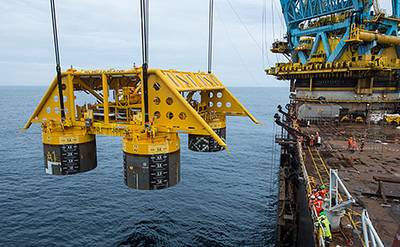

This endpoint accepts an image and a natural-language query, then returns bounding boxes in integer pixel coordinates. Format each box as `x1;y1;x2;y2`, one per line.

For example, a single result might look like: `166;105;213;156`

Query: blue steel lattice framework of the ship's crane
281;0;400;64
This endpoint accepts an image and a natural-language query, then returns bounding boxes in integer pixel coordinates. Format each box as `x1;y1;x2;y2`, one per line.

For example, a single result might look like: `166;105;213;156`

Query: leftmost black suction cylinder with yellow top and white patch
43;129;97;175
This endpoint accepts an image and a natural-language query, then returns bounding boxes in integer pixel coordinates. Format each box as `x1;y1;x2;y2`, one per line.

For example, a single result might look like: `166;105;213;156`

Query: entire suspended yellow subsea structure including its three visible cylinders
24;67;257;190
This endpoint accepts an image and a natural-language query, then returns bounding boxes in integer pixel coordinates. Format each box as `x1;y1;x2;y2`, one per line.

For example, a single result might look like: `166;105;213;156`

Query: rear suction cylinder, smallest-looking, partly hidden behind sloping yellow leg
188;116;226;152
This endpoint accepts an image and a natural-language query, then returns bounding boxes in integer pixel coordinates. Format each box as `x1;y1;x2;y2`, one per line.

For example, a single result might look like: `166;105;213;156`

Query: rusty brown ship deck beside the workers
301;123;400;246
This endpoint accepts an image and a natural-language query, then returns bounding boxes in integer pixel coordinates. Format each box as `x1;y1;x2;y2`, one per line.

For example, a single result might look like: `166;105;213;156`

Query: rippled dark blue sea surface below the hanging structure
0;87;288;247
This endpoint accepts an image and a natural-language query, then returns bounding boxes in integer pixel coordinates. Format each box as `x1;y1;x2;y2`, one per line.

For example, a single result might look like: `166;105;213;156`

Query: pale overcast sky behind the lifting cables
0;0;390;86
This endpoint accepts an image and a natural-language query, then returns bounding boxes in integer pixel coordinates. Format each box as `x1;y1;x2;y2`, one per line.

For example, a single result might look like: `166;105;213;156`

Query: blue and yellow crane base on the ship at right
266;0;400;115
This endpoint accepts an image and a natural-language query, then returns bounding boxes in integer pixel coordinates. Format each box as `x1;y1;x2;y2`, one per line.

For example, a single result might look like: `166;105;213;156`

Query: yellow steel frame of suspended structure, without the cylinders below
24;68;259;151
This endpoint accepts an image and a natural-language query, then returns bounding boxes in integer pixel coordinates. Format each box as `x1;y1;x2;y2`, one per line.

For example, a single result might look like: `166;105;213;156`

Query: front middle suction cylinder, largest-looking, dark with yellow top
123;133;180;190
